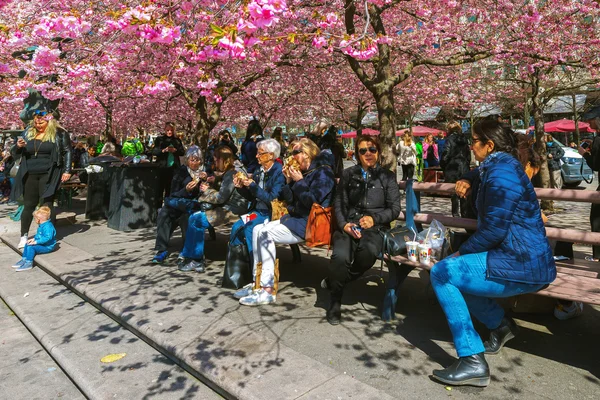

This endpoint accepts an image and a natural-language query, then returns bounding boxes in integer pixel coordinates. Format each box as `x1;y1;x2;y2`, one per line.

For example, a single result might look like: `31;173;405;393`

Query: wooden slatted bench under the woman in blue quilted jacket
382;182;600;320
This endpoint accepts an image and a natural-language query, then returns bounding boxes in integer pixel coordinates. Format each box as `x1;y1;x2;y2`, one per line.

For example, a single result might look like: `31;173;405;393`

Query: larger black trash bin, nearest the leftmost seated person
108;163;161;231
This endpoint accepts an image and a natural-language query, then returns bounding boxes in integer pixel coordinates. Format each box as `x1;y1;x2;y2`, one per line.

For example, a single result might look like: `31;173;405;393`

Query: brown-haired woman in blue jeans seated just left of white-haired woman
179;146;248;272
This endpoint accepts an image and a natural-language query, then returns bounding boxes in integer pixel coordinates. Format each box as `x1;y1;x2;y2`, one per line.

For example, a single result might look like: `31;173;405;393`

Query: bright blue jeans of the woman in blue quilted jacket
431;252;544;357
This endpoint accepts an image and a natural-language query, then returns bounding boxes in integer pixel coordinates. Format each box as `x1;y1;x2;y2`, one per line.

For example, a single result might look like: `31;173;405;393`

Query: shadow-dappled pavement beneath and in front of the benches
2;170;600;400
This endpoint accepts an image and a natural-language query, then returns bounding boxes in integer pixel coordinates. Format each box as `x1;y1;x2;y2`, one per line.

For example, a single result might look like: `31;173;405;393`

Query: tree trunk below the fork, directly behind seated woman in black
373;87;397;172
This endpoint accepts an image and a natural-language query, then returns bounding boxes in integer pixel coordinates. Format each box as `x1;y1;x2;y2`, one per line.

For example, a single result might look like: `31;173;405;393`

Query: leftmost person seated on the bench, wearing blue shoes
152;144;209;263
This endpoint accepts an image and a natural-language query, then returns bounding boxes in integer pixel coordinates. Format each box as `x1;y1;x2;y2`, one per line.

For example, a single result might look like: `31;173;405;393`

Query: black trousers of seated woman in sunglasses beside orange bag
328;228;383;301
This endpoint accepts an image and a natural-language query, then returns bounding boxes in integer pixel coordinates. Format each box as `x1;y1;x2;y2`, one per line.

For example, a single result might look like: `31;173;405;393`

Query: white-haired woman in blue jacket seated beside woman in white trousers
229;139;285;261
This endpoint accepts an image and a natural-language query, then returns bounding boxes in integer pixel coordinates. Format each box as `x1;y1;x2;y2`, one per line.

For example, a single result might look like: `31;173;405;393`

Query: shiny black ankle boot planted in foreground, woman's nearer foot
433;353;490;387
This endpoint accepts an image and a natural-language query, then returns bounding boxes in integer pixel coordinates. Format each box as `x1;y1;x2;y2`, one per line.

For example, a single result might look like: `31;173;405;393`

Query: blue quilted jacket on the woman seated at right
459;152;556;284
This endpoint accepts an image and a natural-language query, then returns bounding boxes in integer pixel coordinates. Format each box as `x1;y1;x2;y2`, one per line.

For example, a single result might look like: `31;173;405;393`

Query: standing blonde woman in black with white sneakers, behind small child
11;110;71;249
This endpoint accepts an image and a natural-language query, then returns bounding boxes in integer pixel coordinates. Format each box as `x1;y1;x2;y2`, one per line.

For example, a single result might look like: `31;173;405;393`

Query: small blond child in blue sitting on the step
12;206;56;272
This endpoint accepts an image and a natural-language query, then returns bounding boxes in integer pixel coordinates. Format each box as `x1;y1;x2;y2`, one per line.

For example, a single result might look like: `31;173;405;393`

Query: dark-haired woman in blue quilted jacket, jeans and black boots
431;120;556;386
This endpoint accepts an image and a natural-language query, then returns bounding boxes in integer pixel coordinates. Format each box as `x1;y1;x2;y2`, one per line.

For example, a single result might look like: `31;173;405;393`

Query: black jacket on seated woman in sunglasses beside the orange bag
334;165;400;231
